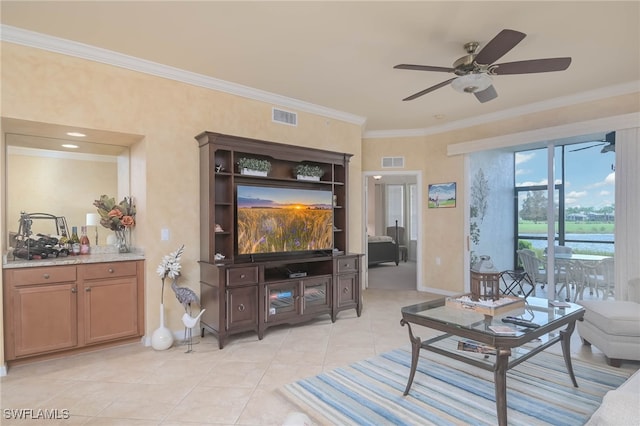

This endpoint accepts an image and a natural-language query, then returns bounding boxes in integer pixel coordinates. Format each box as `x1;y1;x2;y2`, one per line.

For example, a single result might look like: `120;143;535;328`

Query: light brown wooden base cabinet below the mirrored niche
3;261;144;362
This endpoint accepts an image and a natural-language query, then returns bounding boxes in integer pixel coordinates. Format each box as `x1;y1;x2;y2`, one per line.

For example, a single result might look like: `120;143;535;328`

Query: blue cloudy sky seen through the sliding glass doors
516;142;615;208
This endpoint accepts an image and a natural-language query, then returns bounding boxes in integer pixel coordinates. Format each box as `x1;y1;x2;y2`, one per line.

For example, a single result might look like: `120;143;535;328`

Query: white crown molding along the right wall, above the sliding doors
363;80;640;139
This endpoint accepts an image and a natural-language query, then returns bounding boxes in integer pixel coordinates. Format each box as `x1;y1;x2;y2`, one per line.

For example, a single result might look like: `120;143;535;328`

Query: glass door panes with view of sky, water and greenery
515;140;615;256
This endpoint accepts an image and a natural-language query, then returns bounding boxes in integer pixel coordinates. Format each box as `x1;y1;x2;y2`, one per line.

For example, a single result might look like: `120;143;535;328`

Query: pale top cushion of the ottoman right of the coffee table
580;300;640;337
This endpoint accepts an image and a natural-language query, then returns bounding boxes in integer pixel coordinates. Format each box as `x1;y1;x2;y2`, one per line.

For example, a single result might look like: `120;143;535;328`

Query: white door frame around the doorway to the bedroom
361;170;427;291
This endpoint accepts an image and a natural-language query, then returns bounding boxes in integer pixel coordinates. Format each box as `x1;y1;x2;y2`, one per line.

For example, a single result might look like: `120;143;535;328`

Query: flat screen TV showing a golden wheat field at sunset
236;185;333;255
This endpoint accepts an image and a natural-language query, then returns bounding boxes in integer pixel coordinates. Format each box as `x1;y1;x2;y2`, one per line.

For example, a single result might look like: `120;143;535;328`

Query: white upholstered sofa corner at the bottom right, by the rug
585;370;640;426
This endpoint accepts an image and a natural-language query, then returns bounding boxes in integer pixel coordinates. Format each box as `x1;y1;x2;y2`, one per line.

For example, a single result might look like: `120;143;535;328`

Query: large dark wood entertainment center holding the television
196;132;362;349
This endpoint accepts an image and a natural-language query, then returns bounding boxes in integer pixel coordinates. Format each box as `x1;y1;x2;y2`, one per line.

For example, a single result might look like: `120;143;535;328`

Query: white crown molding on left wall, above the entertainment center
0;25;366;127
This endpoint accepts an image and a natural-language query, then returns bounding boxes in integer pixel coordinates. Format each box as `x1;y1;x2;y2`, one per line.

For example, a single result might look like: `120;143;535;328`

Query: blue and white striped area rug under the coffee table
281;348;632;426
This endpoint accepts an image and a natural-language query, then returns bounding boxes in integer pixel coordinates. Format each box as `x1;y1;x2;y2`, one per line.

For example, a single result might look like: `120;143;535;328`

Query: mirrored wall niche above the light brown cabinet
2;119;140;245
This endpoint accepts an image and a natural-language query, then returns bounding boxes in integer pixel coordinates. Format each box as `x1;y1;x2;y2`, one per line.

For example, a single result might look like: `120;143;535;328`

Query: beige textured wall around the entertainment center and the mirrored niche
0;43;362;363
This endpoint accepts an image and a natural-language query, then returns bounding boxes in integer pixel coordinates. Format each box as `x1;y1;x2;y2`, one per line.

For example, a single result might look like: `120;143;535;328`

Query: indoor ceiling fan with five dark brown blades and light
393;29;571;103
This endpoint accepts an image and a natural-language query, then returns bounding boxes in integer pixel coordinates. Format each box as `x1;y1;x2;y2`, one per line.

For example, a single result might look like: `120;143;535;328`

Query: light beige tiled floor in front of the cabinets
0;290;638;425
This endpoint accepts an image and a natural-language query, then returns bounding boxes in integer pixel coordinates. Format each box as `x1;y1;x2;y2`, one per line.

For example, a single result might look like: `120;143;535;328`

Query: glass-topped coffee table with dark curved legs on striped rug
400;296;584;426
